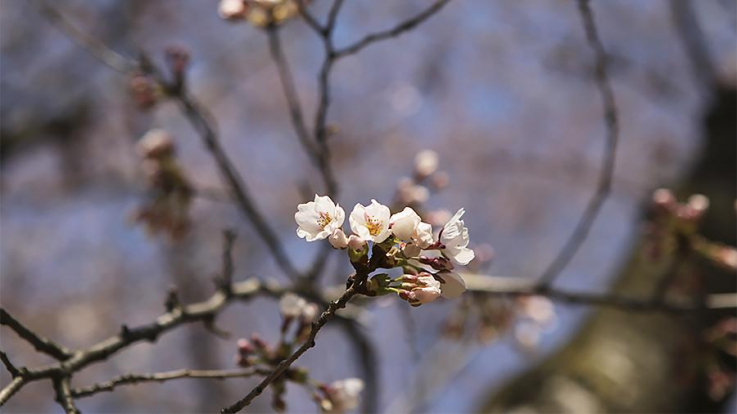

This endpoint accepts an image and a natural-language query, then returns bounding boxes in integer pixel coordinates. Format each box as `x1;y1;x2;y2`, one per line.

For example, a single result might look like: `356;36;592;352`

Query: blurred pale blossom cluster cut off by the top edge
218;0;308;27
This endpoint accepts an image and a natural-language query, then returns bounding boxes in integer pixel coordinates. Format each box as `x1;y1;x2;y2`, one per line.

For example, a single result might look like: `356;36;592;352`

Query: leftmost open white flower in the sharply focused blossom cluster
294;194;345;242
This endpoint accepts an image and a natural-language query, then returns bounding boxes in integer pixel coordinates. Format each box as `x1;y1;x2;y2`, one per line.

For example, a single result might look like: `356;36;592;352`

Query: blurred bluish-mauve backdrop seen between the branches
0;0;737;413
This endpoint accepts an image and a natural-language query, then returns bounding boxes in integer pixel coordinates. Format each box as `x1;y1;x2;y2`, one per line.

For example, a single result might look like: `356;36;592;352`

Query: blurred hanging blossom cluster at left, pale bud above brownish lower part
133;129;193;239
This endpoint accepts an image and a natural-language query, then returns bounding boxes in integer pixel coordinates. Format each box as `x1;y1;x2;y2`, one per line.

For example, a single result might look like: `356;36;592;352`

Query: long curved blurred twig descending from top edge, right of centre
539;0;619;289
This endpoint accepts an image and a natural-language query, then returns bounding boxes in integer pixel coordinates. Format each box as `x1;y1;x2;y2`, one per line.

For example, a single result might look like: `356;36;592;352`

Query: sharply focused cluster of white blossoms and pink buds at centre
294;195;474;306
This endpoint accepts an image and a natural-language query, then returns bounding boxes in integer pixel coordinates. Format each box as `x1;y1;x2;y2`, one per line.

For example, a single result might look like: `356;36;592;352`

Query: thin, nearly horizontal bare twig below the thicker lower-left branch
71;368;270;398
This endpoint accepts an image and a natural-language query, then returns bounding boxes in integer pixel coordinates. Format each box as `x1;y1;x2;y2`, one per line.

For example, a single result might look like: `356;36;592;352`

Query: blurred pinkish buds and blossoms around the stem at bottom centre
236;293;364;414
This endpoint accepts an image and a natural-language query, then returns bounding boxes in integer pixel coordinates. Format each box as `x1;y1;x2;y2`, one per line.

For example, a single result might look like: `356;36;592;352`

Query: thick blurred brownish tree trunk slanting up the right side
482;87;737;413
